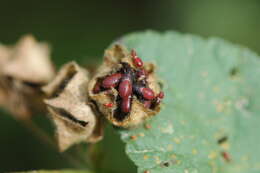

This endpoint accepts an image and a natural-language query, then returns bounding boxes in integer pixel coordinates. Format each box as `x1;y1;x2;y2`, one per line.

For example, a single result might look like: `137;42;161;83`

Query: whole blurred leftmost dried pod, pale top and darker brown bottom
0;35;55;119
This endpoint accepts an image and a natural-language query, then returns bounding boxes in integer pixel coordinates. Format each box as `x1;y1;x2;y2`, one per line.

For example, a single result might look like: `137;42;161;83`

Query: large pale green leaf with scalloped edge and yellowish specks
120;31;260;173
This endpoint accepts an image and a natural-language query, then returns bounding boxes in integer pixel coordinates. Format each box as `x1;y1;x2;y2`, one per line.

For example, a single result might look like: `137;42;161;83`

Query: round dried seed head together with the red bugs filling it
88;45;163;128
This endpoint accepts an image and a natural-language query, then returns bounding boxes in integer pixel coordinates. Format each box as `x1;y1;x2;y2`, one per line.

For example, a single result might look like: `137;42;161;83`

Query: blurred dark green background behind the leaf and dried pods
0;0;260;173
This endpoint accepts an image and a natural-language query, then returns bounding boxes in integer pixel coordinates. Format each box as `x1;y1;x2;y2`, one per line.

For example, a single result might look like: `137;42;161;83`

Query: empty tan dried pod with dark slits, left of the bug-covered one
43;62;103;151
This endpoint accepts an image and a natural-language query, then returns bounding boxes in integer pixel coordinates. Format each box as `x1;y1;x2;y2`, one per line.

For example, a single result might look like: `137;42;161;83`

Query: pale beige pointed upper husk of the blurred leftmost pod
2;35;55;84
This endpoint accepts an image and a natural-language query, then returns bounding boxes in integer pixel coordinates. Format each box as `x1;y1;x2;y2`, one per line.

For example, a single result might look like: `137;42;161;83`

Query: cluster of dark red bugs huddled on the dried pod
93;50;164;120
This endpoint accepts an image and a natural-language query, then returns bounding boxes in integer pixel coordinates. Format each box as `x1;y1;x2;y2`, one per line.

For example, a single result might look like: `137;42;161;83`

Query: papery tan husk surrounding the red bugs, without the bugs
88;45;160;128
